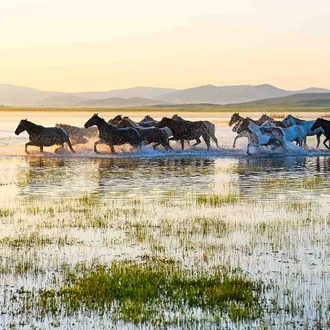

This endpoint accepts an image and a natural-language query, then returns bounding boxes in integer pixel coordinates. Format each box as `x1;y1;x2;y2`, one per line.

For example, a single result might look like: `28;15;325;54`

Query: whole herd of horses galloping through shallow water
15;113;330;154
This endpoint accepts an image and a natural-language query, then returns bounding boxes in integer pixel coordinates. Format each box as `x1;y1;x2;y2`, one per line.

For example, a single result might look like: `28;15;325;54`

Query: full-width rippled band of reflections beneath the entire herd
12;157;330;199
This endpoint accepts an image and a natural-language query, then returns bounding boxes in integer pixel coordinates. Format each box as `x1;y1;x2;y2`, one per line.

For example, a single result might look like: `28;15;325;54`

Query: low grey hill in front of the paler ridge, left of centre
79;97;168;108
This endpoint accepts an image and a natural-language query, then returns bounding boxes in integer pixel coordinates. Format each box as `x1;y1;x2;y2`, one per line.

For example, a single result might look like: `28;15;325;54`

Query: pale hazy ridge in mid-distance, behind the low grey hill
74;87;177;100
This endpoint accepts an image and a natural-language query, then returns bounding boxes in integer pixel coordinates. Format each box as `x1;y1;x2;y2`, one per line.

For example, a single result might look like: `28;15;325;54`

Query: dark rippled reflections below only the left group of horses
17;157;215;198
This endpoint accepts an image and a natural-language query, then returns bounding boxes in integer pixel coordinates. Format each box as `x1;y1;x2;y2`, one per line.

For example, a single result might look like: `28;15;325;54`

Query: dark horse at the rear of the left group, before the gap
155;117;210;150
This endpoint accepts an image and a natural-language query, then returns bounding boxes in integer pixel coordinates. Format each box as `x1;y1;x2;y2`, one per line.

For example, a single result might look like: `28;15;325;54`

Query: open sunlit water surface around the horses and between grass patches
0;112;330;329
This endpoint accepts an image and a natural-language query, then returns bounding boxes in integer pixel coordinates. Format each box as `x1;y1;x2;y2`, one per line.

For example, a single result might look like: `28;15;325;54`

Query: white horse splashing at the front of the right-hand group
237;117;286;155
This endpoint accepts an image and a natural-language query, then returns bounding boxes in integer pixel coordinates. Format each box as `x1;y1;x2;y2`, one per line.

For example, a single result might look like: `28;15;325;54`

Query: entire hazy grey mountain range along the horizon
0;84;330;108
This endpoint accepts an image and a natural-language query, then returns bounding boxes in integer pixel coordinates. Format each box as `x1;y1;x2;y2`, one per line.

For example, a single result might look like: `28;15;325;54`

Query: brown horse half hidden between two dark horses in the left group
116;117;172;150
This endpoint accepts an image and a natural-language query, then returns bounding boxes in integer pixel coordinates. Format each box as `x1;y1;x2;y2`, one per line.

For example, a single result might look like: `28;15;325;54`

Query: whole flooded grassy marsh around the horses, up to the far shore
0;112;330;329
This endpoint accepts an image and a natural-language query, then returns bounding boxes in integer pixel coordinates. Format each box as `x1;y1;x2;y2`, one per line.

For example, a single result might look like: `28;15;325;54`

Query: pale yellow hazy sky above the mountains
0;0;330;92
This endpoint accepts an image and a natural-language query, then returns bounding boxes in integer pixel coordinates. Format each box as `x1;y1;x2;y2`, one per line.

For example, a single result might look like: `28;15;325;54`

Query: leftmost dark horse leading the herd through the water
15;119;75;154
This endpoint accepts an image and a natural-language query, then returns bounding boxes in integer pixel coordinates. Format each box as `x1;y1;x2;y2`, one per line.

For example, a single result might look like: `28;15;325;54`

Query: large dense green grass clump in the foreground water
40;256;263;324
